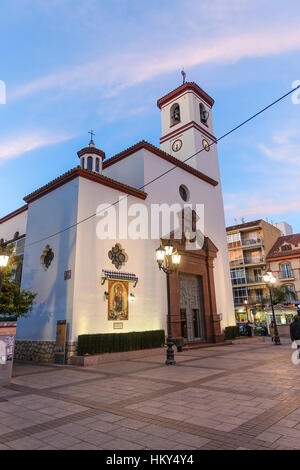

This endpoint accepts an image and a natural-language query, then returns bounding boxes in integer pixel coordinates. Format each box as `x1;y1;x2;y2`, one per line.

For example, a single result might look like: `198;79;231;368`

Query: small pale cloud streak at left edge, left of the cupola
0;131;72;163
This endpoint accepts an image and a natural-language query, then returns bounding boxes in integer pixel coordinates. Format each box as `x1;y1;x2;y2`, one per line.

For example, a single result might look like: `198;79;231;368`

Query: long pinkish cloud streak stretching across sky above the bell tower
9;23;300;100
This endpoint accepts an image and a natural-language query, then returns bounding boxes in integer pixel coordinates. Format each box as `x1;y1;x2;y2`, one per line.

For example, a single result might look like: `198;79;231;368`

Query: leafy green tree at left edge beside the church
0;242;37;319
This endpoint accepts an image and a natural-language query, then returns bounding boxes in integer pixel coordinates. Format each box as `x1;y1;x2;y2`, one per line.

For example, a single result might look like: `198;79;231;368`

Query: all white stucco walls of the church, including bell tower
12;81;235;341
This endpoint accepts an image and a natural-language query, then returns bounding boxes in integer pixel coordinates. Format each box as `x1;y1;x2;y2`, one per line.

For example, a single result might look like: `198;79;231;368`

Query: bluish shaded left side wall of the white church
17;178;78;341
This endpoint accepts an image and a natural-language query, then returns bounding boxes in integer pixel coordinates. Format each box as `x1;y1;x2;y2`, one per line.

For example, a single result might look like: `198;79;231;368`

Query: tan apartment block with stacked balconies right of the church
226;219;281;321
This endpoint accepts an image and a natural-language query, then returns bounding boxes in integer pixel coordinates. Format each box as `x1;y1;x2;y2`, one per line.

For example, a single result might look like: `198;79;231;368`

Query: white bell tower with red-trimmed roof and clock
157;82;220;181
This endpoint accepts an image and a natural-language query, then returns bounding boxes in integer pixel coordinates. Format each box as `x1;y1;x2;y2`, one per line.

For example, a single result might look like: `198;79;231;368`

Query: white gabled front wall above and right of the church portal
98;150;235;327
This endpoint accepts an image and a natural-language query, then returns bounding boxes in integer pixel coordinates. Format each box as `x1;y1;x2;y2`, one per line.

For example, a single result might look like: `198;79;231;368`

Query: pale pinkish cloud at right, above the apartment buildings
224;123;300;222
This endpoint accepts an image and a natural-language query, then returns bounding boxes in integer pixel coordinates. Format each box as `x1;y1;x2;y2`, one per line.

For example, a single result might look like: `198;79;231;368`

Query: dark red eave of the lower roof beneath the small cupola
24;167;147;204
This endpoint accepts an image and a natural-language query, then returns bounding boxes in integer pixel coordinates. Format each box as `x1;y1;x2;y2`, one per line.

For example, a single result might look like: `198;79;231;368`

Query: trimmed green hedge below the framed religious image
78;330;165;356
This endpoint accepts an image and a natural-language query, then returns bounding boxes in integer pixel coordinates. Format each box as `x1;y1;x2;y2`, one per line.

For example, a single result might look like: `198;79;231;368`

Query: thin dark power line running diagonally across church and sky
26;85;300;247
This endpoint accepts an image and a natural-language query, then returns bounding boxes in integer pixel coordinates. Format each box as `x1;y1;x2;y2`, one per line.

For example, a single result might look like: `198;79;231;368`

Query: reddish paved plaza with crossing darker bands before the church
0;339;300;450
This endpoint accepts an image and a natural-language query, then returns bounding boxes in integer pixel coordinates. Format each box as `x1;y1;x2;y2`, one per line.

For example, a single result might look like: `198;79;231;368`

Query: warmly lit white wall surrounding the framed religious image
72;178;167;340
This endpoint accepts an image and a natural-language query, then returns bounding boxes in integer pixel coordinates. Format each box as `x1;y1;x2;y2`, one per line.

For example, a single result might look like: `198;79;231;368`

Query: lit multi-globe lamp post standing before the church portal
156;240;181;365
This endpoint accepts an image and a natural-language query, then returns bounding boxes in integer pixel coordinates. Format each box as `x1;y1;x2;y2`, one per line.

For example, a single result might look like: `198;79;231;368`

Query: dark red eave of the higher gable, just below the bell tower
103;140;219;186
